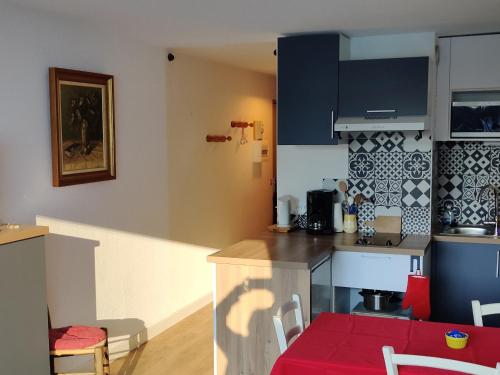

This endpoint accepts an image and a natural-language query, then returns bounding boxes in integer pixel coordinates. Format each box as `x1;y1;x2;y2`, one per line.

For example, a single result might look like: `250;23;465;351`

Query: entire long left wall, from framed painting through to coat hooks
0;2;274;370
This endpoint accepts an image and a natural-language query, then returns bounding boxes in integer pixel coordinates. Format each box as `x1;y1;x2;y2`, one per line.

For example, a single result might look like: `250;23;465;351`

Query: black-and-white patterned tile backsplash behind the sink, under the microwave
438;142;500;224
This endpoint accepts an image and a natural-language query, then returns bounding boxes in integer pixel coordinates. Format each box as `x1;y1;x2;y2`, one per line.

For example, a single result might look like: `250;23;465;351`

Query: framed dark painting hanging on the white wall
49;68;116;186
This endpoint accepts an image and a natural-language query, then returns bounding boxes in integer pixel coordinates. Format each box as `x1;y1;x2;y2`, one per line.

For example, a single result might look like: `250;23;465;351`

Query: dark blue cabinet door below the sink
431;242;500;327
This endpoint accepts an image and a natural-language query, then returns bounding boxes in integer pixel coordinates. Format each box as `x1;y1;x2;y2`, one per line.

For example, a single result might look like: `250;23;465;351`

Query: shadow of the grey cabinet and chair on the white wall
45;234;147;372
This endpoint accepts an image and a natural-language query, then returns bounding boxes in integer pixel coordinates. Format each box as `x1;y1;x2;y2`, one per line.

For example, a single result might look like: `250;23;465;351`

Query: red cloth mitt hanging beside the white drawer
402;275;431;320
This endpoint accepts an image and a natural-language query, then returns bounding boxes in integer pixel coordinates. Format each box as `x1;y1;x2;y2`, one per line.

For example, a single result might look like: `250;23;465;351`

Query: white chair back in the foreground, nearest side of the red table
382;346;500;375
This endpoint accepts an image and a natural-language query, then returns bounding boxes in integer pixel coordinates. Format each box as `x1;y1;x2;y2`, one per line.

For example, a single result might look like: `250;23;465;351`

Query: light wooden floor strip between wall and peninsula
111;305;213;375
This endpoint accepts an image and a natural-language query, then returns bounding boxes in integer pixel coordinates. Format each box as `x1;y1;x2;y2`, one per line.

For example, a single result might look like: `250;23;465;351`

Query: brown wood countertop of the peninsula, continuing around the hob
207;231;431;269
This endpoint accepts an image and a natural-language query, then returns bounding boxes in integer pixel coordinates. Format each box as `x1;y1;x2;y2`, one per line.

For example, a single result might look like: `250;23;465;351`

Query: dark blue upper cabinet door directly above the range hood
339;57;429;117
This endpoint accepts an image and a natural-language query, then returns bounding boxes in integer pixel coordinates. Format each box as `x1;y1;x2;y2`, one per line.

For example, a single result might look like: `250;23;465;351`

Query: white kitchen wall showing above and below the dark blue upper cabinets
277;33;436;210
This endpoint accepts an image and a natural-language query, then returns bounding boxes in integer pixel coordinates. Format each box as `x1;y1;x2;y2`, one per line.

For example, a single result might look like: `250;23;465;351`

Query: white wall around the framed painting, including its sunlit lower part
0;3;188;368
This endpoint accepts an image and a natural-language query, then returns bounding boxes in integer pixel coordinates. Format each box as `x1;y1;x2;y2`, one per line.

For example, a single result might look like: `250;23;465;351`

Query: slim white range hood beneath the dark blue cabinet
335;116;428;132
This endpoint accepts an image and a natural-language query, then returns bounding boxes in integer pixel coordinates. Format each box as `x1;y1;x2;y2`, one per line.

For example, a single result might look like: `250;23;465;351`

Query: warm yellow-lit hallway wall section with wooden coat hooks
167;51;275;248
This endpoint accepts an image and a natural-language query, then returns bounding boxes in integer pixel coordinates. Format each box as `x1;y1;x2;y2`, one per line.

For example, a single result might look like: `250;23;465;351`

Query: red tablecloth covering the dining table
271;313;500;375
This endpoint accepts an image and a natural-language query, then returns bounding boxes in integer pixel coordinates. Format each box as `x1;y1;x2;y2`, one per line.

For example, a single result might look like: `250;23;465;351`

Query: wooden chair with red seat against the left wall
48;316;111;375
